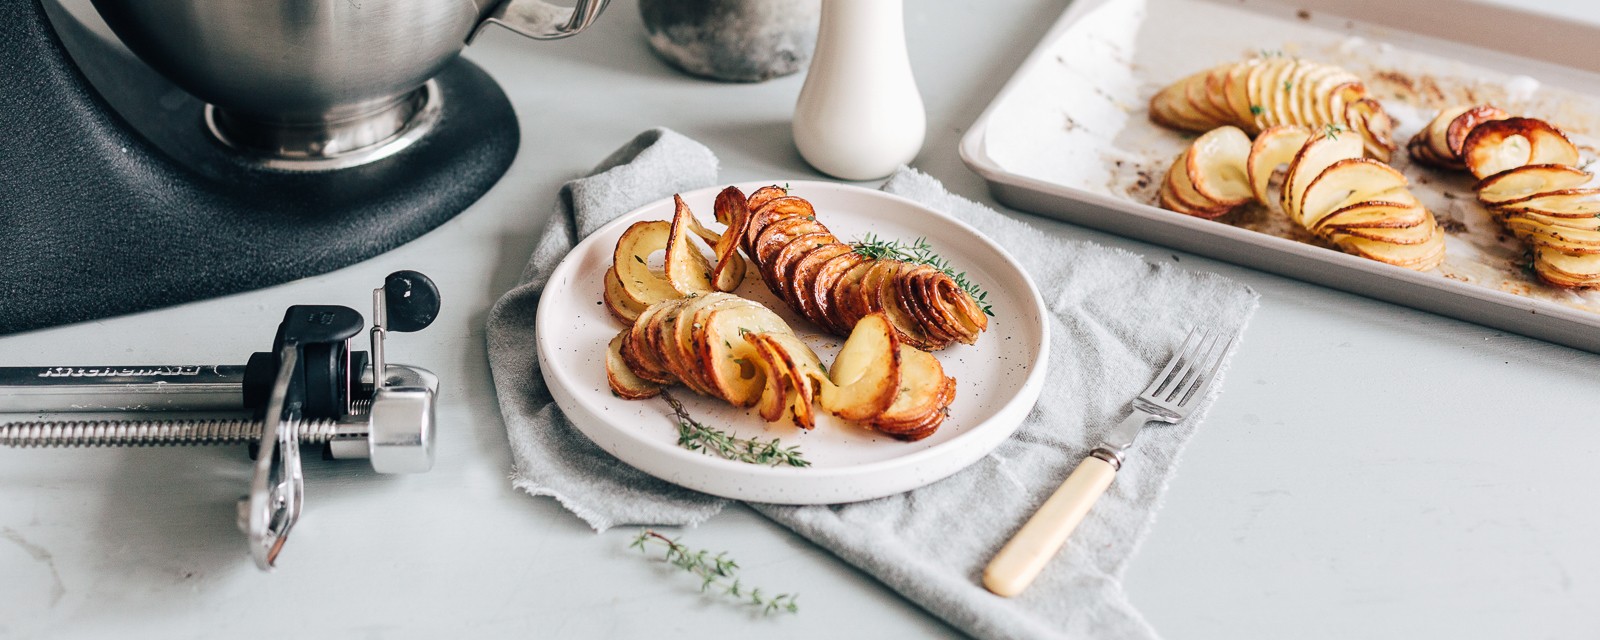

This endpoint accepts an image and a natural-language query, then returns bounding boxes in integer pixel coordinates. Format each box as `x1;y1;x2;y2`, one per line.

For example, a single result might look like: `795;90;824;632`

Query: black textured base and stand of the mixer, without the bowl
0;0;520;334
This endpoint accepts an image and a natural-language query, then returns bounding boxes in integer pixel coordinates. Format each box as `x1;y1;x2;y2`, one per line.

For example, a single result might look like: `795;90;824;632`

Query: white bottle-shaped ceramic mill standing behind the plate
794;0;928;181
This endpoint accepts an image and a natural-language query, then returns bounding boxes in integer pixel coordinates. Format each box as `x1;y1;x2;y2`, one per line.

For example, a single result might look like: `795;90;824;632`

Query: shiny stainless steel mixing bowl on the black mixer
93;0;608;171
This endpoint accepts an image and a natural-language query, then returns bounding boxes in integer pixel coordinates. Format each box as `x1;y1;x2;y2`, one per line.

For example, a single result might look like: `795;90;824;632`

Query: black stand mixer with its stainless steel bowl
0;0;605;334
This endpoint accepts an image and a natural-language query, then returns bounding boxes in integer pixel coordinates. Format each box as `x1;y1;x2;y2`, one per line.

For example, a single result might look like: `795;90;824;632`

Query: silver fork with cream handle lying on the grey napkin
984;328;1234;597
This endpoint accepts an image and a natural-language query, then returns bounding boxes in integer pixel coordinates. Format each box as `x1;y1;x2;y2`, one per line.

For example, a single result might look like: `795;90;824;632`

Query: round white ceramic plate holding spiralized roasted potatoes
534;181;1050;504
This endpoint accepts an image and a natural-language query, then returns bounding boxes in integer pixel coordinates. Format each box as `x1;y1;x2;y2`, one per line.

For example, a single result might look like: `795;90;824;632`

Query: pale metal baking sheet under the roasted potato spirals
960;0;1600;352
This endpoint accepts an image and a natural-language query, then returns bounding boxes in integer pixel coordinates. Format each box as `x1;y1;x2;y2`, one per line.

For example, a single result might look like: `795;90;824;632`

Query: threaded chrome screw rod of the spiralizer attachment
0;418;339;446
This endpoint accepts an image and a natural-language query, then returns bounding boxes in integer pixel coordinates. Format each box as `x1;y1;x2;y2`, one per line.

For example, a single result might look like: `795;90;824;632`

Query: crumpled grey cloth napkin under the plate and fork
488;130;1256;638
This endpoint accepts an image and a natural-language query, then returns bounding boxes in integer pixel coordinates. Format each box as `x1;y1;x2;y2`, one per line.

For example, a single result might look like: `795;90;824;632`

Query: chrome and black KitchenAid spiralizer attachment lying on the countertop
0;270;440;571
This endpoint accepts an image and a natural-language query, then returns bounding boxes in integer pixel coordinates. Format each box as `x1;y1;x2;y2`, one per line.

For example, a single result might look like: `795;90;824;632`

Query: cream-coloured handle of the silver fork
984;456;1117;598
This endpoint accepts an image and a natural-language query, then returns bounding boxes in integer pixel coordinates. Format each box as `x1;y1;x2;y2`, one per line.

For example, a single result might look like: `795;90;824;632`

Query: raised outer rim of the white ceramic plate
534;179;1050;504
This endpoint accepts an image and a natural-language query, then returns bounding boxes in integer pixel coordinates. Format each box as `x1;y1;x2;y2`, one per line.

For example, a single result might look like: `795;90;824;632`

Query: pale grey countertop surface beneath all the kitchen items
0;0;1600;638
